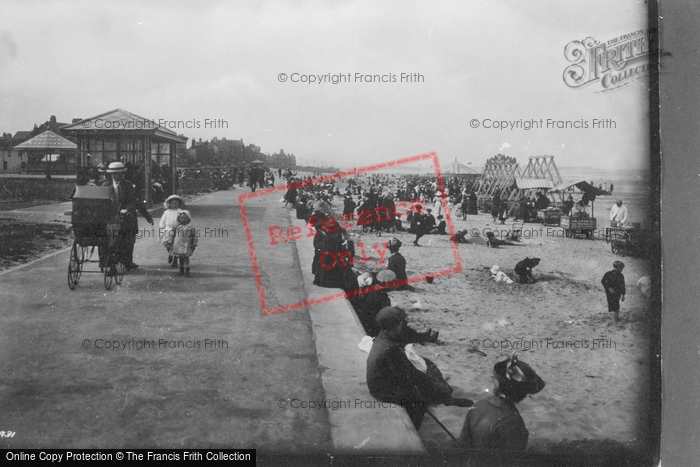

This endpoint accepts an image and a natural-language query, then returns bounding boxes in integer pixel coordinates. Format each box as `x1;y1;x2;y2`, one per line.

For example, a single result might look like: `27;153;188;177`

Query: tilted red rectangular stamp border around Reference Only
238;152;462;315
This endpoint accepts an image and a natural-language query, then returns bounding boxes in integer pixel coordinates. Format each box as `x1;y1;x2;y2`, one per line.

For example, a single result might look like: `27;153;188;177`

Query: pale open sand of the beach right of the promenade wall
334;182;650;458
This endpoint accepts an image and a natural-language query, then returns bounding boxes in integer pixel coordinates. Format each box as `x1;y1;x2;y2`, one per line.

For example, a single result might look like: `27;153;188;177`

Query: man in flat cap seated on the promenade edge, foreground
367;307;474;430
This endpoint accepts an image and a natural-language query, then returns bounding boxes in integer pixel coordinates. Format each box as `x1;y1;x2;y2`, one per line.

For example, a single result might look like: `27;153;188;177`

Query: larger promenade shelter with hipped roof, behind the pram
61;109;187;205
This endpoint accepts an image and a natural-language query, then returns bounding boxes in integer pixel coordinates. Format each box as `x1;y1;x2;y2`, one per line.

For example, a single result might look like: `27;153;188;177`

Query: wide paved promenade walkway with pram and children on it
0;190;330;453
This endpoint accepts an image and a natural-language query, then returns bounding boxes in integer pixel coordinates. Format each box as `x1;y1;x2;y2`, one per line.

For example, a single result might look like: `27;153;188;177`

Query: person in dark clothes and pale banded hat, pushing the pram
107;162;153;270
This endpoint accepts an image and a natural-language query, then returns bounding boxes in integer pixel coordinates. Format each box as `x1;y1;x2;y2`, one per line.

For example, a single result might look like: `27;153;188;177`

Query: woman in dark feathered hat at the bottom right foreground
459;355;545;451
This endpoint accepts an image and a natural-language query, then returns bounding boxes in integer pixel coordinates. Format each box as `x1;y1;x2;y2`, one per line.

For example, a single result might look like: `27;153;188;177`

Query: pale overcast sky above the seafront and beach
0;0;649;168
